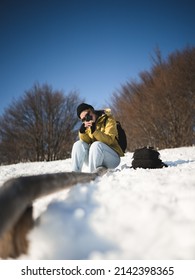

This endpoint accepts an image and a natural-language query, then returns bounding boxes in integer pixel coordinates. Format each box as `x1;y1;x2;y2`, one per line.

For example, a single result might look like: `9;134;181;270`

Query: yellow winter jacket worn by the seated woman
79;110;124;157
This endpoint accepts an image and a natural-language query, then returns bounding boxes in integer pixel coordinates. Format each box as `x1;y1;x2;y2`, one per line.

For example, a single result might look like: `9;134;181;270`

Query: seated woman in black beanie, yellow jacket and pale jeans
72;103;124;172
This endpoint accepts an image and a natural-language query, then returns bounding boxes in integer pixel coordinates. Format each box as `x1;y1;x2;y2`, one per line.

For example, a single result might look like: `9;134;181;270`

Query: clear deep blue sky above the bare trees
0;0;195;113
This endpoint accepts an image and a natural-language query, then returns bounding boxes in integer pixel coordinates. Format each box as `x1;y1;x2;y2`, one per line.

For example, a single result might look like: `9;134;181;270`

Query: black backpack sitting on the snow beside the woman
132;147;167;169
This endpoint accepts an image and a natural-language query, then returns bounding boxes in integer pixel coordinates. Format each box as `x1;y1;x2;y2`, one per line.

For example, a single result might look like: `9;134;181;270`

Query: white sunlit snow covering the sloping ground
0;147;195;260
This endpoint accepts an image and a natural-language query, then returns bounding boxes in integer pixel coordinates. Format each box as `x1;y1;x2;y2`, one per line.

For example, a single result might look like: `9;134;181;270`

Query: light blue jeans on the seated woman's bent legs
72;140;120;172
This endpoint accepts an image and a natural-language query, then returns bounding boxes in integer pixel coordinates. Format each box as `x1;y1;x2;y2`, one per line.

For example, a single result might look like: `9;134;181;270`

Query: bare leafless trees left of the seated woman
0;84;81;164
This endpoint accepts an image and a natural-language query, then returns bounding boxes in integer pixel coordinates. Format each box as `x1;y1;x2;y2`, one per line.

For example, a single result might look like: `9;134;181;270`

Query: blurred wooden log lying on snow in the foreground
0;167;106;258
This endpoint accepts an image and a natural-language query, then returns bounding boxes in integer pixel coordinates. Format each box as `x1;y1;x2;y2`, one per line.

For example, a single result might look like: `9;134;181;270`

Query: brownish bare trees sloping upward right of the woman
111;47;195;151
